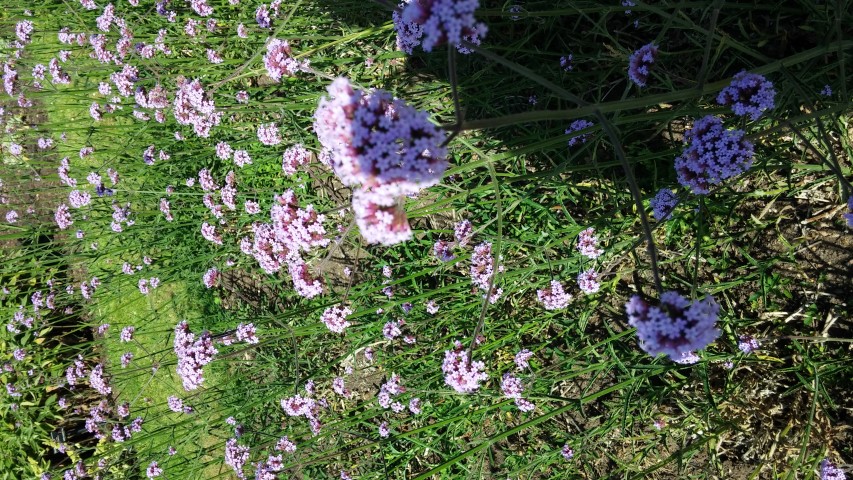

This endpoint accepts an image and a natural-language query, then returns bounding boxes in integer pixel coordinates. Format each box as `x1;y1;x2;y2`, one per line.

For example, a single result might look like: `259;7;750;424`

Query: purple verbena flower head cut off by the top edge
393;0;488;53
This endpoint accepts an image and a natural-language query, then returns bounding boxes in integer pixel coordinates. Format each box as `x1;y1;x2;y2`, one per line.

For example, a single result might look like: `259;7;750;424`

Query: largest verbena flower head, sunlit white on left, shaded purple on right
314;78;447;196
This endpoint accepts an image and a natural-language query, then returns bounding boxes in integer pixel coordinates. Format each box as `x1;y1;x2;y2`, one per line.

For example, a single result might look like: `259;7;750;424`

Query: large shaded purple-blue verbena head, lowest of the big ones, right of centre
625;291;720;361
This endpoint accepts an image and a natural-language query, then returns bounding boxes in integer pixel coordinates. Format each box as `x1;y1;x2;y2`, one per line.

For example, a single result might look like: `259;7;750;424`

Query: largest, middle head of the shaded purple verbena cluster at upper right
675;115;753;195
